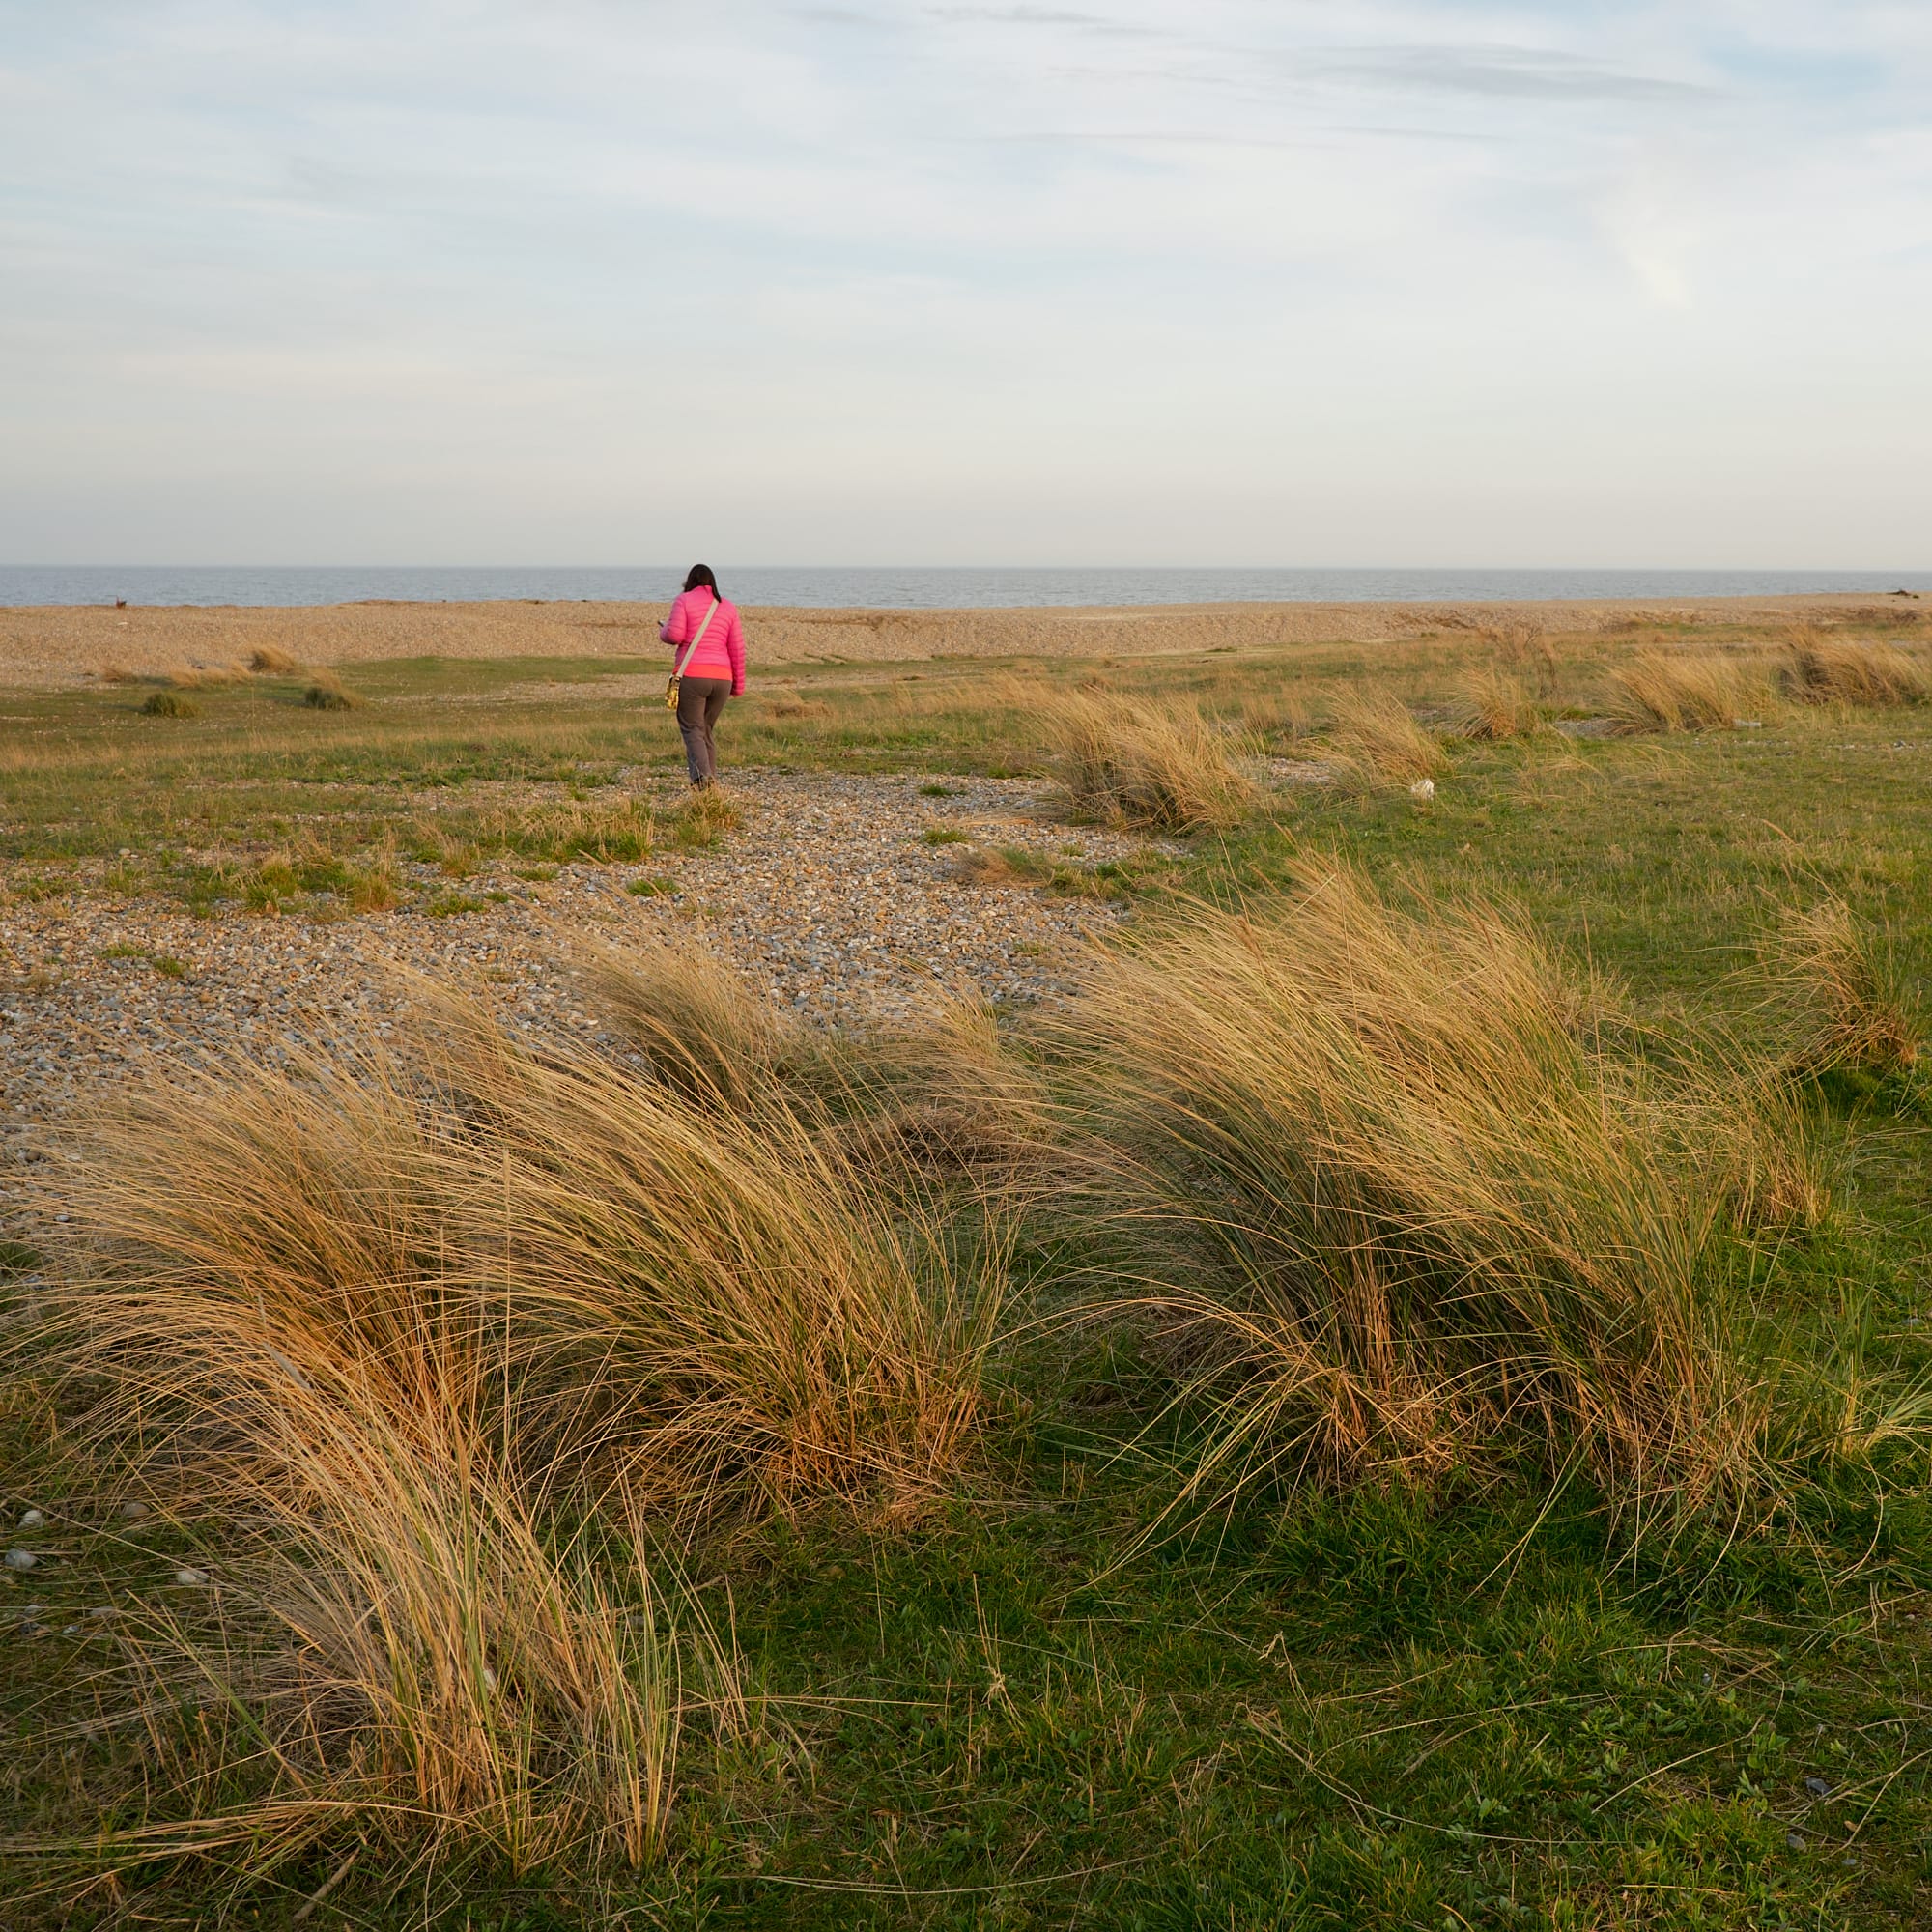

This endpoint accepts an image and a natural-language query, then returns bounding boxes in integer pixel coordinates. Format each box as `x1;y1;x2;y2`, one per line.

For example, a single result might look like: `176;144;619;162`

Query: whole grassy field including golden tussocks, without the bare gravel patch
0;622;1932;1932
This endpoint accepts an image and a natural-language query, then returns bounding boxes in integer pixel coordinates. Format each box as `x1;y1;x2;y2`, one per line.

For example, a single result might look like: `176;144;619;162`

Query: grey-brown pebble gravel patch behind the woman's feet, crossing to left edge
0;773;1146;1225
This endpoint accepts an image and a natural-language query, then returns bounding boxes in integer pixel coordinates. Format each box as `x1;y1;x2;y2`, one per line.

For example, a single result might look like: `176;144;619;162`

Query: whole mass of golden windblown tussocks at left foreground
22;964;1001;1876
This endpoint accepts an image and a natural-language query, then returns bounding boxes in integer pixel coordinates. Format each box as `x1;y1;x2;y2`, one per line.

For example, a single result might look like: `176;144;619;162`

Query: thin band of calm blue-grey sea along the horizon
0;562;1932;611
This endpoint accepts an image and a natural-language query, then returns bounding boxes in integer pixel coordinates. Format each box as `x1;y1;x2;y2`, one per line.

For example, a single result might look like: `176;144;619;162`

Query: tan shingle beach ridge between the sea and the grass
0;591;1909;690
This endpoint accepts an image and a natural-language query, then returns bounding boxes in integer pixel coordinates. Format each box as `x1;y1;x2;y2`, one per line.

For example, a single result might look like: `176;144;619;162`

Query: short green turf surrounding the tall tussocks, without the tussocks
0;628;1932;1932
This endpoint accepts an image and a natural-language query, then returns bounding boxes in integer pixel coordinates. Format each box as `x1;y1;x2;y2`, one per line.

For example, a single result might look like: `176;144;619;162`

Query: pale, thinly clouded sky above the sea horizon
0;0;1932;568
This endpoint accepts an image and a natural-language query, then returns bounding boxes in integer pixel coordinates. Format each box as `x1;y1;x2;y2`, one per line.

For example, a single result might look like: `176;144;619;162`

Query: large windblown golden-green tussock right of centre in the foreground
1063;869;1766;1522
